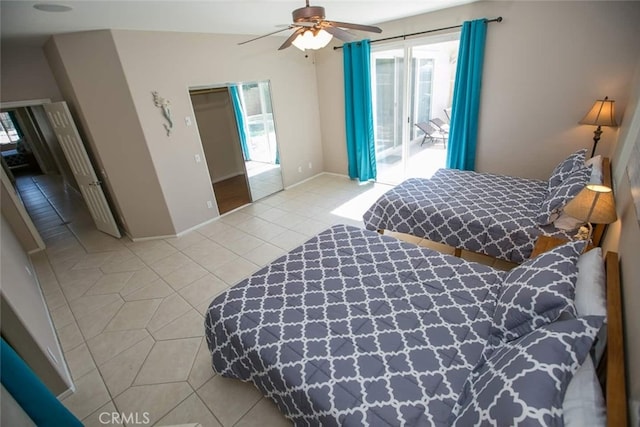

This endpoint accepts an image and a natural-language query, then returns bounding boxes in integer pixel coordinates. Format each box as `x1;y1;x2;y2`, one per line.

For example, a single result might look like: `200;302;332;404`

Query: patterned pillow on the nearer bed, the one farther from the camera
489;240;585;347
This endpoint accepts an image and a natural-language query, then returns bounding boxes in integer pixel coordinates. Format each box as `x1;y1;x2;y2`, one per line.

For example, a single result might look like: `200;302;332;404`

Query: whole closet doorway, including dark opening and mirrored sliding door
189;80;284;214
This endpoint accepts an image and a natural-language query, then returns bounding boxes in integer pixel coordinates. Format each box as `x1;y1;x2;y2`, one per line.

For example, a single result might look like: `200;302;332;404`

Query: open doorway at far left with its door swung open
0;100;121;244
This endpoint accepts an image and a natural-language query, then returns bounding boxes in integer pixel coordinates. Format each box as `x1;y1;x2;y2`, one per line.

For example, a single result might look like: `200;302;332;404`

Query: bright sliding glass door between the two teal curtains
371;33;460;184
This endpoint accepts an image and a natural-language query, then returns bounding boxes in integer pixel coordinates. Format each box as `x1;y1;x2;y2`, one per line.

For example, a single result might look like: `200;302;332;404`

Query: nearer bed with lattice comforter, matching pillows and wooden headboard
205;225;626;426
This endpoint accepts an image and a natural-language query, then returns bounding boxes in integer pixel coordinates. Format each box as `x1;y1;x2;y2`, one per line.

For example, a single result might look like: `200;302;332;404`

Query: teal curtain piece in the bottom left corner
0;339;82;427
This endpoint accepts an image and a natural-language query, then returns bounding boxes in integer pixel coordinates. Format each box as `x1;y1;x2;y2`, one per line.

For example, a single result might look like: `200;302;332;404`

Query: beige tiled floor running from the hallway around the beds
18;174;512;426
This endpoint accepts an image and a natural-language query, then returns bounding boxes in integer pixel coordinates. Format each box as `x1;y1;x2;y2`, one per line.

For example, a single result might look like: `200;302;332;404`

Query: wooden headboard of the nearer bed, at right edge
598;252;628;427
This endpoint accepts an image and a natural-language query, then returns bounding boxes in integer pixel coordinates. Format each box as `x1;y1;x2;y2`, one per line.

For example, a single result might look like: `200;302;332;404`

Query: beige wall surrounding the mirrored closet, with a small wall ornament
31;31;323;237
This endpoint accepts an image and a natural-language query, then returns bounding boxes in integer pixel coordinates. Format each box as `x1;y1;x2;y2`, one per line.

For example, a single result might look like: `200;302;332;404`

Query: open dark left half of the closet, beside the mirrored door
189;86;252;215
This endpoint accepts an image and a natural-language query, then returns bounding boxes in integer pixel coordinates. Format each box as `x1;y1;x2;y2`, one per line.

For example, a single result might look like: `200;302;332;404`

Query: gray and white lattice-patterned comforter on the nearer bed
205;225;504;426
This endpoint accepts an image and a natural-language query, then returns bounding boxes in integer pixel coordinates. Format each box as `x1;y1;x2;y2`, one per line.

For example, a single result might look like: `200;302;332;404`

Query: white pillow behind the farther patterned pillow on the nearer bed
575;247;607;316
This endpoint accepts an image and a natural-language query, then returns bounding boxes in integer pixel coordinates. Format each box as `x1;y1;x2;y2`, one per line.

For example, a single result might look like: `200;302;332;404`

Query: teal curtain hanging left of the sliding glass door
342;40;376;182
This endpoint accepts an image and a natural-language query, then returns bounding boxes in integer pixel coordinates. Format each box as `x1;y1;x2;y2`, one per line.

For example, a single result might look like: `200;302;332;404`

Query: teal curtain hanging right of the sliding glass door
447;19;487;170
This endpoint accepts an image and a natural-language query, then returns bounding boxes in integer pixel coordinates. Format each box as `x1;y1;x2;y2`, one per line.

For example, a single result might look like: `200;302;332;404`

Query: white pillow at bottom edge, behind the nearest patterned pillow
562;357;607;427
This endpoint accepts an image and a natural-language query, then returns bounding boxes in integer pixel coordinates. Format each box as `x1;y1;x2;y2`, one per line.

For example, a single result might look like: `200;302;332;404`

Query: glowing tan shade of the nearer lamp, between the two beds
564;184;617;224
